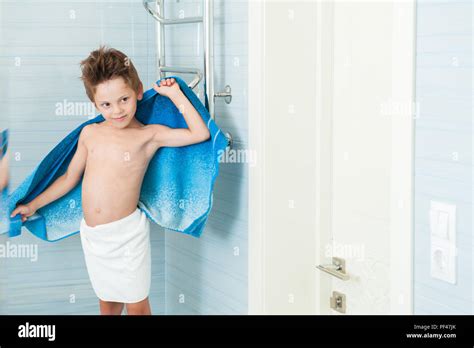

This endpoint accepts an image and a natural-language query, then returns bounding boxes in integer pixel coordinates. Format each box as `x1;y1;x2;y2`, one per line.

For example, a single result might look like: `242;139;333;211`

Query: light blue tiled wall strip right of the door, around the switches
414;0;474;314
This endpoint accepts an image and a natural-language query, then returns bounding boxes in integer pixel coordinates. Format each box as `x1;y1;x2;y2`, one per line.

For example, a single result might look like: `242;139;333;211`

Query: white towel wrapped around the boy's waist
80;208;151;303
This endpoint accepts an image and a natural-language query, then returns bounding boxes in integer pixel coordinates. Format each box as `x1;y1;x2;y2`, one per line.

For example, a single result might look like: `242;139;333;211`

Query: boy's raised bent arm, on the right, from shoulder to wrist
153;89;210;147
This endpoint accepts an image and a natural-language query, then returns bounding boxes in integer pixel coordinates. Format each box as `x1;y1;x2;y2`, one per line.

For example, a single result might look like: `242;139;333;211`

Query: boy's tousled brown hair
81;46;141;103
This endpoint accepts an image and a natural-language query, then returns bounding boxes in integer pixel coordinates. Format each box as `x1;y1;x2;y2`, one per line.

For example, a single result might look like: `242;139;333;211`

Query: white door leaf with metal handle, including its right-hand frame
316;1;415;314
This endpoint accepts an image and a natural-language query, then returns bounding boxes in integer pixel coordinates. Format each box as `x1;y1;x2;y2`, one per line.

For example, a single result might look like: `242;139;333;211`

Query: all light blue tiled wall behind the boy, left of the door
0;0;248;314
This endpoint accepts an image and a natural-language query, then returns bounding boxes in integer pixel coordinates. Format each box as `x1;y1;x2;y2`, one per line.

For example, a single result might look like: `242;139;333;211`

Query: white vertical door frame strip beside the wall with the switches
390;0;417;314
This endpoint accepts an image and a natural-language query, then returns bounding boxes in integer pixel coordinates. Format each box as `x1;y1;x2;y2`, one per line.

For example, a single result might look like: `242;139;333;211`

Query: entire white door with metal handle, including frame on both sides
248;0;414;314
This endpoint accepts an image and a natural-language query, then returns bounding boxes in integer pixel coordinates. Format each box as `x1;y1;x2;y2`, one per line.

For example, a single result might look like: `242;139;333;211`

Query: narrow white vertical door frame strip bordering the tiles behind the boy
247;0;266;315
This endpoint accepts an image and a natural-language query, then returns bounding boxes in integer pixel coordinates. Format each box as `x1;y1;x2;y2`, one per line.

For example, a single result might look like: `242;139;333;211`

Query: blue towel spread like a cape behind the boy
8;76;228;241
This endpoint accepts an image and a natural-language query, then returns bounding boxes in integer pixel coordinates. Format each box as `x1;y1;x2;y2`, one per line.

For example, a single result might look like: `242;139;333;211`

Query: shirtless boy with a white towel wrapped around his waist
11;47;210;314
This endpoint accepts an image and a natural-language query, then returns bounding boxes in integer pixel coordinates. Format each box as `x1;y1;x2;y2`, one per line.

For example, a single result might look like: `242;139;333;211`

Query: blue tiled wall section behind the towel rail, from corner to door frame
165;0;248;314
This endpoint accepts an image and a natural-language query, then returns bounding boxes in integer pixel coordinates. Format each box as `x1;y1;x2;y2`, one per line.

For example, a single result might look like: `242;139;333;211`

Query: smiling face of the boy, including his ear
94;77;143;128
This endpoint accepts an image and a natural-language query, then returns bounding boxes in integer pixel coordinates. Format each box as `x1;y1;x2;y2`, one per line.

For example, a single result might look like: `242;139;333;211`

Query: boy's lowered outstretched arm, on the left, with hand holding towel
11;126;87;221
